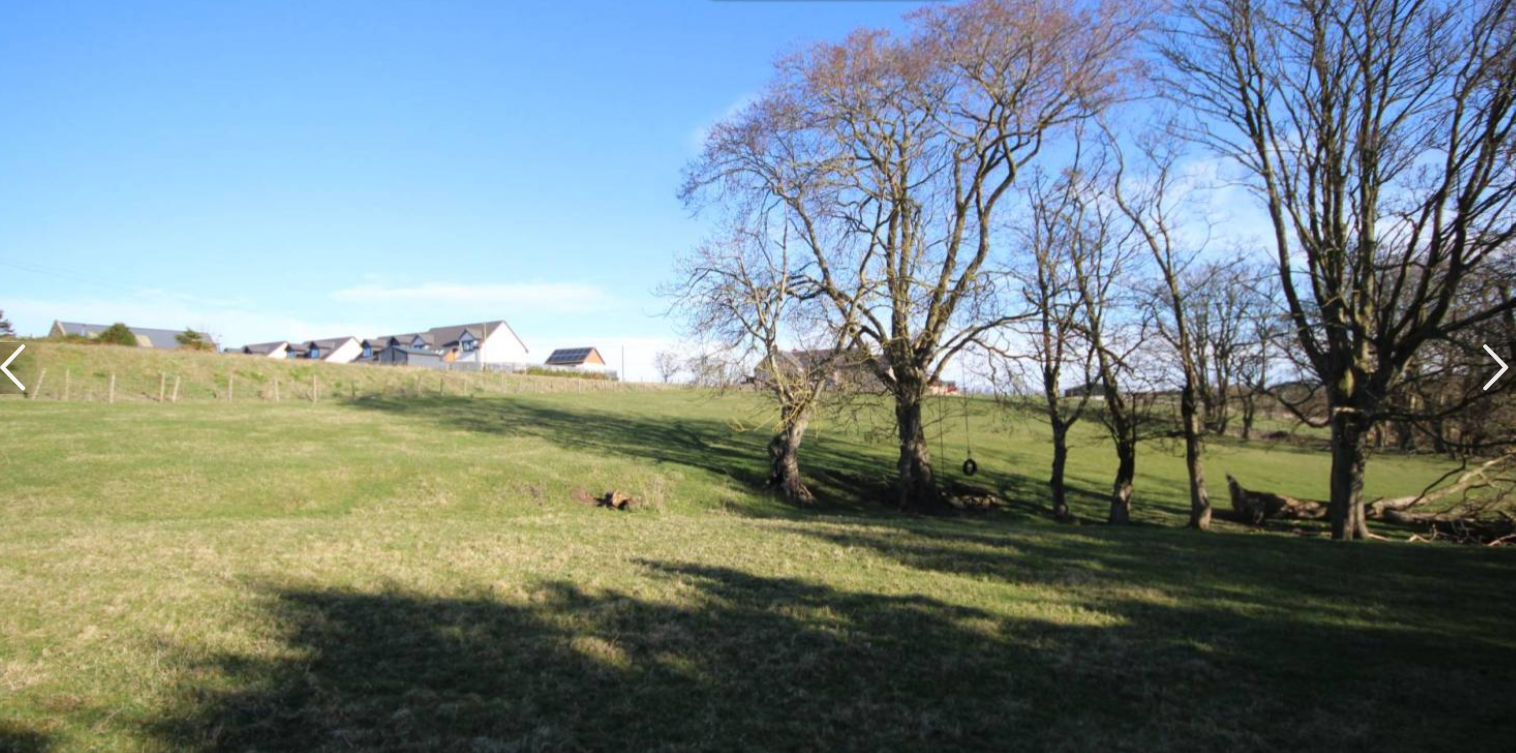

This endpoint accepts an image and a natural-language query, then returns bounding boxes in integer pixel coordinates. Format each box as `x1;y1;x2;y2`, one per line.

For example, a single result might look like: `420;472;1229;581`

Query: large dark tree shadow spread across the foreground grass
153;532;1516;751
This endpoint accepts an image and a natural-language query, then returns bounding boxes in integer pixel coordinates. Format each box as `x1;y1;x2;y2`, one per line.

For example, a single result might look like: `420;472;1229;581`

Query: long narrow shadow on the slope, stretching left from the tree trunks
344;397;1105;517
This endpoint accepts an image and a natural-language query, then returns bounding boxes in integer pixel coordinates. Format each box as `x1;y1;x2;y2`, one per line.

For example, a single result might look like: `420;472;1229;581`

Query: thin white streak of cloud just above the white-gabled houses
332;282;609;312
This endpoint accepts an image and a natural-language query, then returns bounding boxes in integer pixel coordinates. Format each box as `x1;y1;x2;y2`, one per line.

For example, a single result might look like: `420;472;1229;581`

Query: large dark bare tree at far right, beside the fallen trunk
1163;0;1516;539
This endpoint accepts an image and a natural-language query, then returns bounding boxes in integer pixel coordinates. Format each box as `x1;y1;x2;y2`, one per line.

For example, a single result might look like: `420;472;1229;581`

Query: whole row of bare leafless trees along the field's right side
664;0;1516;539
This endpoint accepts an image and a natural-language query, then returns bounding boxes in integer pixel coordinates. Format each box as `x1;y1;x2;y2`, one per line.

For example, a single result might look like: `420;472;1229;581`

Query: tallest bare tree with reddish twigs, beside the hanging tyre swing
685;0;1139;511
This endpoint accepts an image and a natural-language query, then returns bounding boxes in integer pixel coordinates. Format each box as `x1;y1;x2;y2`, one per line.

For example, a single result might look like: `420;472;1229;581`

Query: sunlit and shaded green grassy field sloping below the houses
0;355;1516;751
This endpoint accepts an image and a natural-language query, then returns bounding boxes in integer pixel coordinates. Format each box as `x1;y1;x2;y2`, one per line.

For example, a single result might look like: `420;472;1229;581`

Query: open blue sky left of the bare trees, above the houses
0;0;913;377
